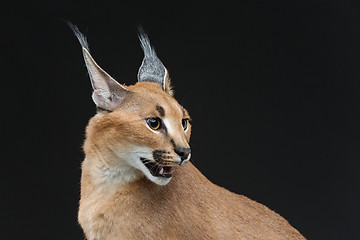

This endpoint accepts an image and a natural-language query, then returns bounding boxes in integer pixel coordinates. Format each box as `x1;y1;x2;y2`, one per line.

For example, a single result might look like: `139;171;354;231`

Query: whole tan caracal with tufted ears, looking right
69;24;304;240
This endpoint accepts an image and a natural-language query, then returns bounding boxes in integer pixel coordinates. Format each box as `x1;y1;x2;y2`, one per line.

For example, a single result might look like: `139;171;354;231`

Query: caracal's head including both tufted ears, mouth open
71;25;191;185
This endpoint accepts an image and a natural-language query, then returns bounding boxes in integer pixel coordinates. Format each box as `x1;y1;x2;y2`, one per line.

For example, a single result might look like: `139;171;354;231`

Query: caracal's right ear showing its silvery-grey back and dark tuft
138;27;173;95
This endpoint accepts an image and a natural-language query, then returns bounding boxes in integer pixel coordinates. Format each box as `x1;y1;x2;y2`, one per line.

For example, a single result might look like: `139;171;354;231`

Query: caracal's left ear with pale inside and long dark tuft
68;22;130;111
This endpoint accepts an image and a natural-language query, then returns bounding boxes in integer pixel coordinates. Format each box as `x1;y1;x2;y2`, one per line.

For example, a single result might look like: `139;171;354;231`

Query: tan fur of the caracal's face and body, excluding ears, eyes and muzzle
79;82;304;240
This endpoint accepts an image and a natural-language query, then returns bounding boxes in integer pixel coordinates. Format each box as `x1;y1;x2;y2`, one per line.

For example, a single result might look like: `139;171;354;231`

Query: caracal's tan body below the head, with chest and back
79;161;304;240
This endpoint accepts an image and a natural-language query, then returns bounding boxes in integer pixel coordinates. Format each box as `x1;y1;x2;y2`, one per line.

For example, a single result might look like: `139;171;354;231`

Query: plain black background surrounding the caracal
0;0;360;239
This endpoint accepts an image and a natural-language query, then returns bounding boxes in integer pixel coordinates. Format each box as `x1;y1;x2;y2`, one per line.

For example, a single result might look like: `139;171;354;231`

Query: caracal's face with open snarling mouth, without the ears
87;82;191;185
